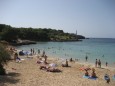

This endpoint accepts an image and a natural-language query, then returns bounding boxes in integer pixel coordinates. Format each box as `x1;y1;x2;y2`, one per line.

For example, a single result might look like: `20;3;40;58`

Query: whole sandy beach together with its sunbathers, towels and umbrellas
0;47;115;86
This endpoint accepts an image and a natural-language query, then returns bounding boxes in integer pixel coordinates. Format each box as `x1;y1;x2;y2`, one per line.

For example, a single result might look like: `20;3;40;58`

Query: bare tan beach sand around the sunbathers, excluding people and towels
0;53;115;86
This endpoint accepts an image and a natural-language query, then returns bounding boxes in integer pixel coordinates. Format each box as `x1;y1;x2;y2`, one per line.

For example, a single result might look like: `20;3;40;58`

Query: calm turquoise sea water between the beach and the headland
17;38;115;66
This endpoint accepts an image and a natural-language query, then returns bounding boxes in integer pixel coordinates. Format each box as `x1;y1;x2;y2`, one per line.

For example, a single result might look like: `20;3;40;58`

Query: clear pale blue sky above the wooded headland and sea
0;0;115;38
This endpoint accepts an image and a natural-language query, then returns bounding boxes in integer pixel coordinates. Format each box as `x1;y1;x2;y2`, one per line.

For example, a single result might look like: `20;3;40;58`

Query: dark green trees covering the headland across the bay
0;24;85;42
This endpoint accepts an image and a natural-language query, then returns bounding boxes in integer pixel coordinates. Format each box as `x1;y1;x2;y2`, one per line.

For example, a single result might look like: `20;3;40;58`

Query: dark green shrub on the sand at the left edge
0;44;11;75
